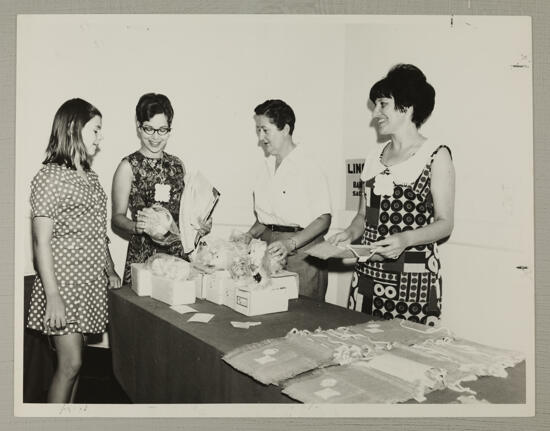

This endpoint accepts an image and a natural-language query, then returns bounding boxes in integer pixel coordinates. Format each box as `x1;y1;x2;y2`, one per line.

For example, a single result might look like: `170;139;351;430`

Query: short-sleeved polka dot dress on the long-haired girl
27;163;108;335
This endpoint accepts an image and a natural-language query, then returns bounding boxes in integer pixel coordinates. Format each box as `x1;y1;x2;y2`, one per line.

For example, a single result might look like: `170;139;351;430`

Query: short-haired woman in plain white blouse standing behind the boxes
247;100;331;301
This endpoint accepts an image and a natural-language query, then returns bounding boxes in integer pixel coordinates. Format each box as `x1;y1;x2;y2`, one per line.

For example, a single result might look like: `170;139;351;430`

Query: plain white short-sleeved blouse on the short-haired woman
254;145;331;228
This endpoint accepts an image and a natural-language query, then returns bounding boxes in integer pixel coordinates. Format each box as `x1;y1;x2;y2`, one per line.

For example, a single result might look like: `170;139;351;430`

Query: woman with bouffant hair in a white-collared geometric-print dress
329;64;455;326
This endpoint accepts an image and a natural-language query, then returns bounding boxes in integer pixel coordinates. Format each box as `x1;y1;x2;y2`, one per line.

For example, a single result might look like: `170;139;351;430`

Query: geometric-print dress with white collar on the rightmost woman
348;142;450;326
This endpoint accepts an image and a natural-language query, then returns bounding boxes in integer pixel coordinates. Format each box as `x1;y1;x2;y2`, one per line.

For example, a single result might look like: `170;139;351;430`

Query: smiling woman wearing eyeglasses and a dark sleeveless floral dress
111;93;210;284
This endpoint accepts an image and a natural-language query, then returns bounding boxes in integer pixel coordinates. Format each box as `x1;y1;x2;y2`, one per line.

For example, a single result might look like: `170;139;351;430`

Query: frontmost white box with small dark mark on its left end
233;285;288;316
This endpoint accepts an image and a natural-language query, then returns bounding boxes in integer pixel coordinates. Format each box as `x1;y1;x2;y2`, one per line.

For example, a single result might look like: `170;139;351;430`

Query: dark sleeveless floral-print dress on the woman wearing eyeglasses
123;151;186;284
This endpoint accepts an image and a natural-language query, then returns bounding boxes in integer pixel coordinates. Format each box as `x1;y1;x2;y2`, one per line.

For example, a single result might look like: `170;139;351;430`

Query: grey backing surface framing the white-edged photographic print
0;0;550;430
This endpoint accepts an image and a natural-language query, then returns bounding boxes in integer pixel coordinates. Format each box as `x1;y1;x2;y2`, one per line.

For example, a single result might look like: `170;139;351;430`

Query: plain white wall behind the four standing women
16;15;534;353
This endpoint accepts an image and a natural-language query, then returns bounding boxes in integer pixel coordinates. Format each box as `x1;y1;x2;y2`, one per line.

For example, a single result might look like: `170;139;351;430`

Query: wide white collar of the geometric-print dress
361;140;440;186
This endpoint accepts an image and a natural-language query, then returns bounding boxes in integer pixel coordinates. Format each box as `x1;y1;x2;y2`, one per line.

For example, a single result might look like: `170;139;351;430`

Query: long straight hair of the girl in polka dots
42;98;101;170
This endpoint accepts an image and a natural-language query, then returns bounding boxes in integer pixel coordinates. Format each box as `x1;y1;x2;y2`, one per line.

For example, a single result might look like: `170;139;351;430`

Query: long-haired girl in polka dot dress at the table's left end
27;99;120;403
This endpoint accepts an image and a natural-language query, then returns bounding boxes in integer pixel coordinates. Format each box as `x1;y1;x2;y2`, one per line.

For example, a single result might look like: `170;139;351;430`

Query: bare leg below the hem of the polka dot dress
48;334;84;403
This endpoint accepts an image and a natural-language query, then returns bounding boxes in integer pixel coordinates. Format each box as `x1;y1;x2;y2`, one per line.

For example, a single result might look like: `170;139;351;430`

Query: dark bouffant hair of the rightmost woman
369;64;435;128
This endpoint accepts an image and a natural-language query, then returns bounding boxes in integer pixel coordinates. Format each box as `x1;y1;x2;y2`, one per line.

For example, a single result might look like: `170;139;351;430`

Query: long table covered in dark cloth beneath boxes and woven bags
109;286;525;404
